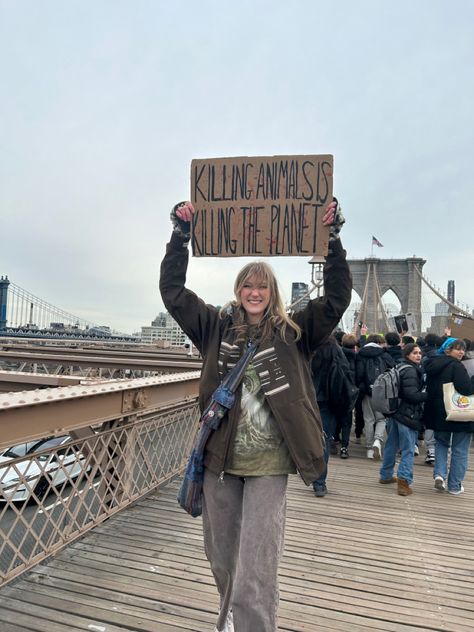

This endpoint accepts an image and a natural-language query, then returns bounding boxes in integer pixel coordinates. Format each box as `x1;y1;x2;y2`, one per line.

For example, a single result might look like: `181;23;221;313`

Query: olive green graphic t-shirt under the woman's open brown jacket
226;364;296;476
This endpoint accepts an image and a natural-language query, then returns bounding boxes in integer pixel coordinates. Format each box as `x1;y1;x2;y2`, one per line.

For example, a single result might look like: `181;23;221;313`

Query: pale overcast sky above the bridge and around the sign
0;0;474;332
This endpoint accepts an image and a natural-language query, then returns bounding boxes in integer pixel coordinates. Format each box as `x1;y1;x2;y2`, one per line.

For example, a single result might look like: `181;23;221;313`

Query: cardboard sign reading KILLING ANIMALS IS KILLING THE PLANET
191;155;333;257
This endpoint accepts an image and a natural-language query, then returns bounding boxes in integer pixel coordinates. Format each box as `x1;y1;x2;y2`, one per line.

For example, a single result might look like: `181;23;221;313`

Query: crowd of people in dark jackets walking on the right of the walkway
312;330;474;497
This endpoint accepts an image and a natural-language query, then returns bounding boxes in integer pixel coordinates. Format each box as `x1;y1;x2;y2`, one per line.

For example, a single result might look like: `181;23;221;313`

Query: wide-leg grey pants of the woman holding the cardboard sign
202;469;288;632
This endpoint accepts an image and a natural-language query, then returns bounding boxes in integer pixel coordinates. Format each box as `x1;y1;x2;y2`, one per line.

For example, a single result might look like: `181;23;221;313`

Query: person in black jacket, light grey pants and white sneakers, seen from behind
356;334;395;459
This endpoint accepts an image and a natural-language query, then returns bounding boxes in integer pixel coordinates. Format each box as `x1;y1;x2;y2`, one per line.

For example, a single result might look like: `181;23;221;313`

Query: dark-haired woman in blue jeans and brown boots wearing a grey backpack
379;343;427;496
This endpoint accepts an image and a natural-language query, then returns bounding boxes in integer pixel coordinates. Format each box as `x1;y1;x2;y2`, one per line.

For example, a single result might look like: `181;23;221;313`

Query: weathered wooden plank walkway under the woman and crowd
0;446;474;632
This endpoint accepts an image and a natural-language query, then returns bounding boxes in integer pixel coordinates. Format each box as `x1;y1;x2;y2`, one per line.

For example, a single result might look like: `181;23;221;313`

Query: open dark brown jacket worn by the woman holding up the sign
160;234;352;485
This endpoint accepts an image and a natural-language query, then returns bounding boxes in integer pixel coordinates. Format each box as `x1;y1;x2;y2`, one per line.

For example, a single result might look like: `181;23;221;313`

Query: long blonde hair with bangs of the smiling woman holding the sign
220;261;301;342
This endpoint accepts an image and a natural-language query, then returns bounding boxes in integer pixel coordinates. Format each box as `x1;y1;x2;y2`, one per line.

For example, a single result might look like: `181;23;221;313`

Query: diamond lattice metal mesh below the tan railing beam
0;400;199;586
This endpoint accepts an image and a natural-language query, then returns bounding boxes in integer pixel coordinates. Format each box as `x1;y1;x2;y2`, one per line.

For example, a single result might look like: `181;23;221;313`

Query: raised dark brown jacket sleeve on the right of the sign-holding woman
293;239;352;357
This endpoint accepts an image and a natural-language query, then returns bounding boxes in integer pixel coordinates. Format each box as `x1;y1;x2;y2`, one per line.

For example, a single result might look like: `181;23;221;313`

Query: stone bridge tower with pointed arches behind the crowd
348;257;426;334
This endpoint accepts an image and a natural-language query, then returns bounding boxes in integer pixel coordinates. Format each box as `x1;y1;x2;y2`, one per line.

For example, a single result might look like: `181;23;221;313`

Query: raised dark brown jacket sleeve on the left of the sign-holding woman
160;233;219;354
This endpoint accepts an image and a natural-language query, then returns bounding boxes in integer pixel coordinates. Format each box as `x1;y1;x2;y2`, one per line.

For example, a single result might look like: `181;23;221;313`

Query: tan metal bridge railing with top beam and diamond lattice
0;372;199;586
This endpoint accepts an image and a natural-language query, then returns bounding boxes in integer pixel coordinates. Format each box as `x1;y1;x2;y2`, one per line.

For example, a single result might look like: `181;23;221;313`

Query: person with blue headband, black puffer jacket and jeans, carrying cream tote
423;338;474;495
